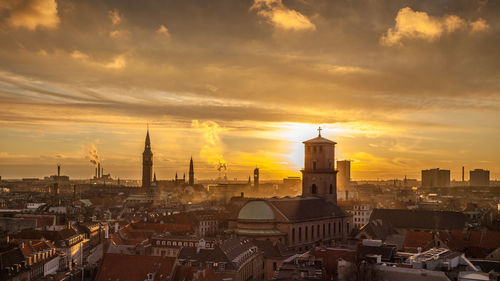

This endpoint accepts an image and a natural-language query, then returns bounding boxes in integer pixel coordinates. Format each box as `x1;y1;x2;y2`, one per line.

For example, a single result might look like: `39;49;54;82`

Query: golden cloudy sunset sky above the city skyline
0;0;500;180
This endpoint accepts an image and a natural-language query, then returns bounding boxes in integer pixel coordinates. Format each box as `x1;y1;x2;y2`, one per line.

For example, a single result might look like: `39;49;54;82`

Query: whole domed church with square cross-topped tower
229;129;352;251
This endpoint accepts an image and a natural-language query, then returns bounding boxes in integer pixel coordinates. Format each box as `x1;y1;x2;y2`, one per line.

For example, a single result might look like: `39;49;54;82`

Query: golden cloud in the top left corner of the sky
0;0;60;30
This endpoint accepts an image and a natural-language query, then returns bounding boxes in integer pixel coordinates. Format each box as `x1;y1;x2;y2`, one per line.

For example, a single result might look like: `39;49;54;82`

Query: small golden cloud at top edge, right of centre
251;0;316;30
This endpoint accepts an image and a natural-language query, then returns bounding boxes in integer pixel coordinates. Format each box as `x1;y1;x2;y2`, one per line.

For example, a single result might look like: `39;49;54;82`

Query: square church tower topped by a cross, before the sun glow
301;127;337;204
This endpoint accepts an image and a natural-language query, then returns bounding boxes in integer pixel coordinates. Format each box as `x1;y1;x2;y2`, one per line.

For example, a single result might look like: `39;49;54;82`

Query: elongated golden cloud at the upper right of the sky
380;7;488;46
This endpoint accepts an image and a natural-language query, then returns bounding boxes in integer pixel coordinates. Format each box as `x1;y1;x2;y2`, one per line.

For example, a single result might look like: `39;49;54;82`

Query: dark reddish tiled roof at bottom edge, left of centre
95;253;175;281
